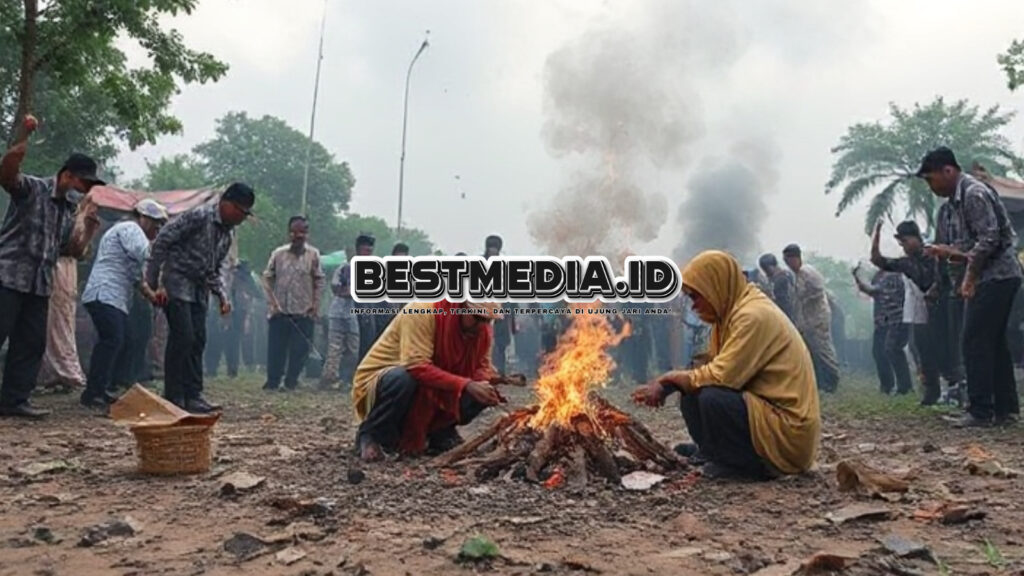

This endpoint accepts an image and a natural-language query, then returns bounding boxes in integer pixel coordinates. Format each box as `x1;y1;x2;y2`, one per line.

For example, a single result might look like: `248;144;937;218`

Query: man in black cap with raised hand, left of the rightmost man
871;220;953;406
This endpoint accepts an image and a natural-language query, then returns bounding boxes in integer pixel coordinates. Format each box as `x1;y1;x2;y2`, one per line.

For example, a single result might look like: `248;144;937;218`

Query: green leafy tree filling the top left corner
0;0;227;171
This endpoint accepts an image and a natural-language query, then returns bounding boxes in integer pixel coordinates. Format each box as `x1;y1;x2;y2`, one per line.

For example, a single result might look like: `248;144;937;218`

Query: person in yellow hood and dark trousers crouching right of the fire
634;251;821;479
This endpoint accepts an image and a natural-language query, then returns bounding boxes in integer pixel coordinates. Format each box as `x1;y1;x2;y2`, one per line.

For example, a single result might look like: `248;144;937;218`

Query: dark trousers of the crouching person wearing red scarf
355;368;485;451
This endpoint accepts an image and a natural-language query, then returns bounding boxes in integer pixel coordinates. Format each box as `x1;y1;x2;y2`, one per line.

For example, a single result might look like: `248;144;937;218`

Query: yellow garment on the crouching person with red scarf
352;302;436;422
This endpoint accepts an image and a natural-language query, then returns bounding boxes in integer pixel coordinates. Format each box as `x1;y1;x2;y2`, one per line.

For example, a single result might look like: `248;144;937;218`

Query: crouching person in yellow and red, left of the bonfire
352;301;502;461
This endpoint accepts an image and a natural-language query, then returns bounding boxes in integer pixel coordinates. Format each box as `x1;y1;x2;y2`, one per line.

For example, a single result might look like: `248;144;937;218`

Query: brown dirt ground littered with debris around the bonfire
0;376;1024;576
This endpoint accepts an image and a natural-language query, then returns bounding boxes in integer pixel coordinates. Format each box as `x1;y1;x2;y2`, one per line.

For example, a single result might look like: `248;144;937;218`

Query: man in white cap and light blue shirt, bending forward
81;199;167;412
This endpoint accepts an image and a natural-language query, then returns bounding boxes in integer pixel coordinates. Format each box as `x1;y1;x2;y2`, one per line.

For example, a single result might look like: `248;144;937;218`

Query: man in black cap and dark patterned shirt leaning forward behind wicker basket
145;182;256;414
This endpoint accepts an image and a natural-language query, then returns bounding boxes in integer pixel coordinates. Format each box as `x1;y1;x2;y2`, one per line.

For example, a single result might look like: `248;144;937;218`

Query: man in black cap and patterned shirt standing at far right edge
918;147;1024;427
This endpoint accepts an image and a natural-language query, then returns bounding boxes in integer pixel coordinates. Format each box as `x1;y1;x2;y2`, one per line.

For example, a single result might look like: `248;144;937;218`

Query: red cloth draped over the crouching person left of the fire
398;301;494;454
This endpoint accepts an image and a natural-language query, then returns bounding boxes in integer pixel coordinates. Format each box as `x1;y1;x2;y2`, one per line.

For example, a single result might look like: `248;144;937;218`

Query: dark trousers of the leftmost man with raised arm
0;286;50;406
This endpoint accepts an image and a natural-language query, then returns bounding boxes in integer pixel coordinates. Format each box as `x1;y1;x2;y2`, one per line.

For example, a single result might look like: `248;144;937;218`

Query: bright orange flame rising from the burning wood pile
529;304;631;429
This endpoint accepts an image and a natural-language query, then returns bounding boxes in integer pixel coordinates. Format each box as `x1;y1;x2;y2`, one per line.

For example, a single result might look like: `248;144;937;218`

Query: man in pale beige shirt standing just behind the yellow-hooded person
782;244;840;392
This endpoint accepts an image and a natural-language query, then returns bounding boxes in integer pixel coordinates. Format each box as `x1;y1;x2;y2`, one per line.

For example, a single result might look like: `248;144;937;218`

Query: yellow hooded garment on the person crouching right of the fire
683;251;821;474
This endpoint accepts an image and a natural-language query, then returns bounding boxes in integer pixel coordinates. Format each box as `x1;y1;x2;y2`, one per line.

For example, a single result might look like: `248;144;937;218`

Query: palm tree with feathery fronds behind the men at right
825;97;1022;234
